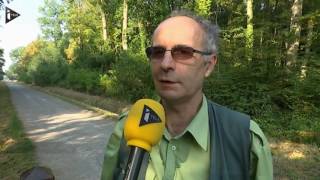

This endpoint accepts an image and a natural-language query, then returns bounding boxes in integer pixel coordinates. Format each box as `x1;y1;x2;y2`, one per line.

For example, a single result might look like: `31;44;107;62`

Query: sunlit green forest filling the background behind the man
1;0;320;145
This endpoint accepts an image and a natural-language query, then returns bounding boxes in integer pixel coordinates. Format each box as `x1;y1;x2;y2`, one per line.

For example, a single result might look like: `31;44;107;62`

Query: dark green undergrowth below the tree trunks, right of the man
204;53;320;143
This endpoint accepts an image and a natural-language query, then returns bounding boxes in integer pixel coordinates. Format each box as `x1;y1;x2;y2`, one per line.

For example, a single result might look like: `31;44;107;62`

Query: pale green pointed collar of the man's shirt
164;95;209;151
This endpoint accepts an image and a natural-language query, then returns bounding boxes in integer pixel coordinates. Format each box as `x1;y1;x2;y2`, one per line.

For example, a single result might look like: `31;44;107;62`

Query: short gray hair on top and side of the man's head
168;10;219;60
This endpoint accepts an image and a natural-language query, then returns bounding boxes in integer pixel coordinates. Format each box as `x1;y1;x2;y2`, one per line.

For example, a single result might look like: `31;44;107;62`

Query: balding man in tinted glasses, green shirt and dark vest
102;11;273;180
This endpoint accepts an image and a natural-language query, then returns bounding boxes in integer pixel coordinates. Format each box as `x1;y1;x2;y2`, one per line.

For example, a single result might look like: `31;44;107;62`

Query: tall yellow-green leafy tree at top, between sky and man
63;0;103;63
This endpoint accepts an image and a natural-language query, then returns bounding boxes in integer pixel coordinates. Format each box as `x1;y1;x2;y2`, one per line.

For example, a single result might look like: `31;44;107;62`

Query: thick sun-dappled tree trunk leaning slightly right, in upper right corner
286;0;303;67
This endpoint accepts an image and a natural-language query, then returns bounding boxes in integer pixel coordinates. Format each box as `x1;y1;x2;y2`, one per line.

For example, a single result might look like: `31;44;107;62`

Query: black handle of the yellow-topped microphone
124;146;146;180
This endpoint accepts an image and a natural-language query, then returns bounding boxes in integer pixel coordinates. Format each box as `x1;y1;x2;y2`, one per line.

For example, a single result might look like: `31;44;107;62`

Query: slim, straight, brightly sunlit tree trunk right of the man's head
246;0;253;62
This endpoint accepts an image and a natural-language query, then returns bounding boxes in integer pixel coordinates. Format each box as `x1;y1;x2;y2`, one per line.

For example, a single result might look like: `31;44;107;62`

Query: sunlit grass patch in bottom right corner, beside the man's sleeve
269;138;320;180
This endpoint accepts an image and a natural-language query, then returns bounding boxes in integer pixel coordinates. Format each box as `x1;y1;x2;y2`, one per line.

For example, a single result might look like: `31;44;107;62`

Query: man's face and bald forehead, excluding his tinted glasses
151;16;216;101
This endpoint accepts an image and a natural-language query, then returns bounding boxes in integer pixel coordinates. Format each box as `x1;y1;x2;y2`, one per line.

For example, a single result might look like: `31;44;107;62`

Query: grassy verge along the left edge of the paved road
0;82;36;180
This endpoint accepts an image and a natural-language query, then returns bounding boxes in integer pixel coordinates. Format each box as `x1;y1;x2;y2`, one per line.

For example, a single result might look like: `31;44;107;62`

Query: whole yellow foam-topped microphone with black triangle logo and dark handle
124;99;165;180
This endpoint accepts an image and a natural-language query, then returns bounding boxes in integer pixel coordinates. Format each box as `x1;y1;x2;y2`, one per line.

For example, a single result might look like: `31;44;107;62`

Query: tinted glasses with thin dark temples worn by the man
146;45;212;60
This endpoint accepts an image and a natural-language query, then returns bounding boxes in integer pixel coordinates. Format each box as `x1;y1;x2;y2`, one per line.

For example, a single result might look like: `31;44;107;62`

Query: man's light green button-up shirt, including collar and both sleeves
101;96;273;180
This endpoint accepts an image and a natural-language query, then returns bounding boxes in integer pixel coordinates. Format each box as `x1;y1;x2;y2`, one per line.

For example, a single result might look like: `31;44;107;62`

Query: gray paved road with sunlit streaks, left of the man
7;82;114;180
